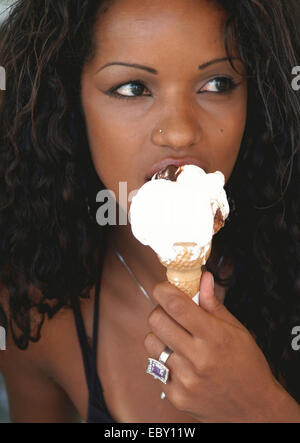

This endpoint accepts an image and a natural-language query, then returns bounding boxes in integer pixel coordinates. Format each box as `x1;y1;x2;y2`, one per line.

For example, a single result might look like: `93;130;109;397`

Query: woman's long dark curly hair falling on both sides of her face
0;0;300;402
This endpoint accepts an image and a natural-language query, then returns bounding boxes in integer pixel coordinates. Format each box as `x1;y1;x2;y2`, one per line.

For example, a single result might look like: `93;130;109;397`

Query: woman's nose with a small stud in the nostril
151;102;201;151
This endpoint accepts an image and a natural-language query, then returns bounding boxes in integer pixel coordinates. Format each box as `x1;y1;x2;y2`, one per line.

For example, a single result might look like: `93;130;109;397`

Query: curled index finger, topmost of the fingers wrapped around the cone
153;282;212;337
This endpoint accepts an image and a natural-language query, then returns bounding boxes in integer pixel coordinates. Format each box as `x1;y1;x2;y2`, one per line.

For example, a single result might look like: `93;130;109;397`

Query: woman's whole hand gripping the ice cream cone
144;272;285;422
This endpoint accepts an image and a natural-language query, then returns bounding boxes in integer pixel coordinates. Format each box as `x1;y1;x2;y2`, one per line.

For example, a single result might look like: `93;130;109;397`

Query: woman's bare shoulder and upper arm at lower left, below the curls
0;285;88;422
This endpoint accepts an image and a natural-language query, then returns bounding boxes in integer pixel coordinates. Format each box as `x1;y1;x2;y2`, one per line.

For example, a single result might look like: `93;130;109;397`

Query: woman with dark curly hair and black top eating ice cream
0;0;300;423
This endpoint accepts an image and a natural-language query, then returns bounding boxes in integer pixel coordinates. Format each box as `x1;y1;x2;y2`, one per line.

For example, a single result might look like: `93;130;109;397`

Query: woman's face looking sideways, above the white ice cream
81;0;247;196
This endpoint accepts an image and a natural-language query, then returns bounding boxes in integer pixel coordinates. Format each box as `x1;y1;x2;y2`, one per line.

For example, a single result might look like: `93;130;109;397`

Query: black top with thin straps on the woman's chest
73;246;116;423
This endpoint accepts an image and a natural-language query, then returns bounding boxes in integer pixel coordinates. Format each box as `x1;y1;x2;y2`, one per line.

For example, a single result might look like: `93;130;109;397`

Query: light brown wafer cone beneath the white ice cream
158;242;211;298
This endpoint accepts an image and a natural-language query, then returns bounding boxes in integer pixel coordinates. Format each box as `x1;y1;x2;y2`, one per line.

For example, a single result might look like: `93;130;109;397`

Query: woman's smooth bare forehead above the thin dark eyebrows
94;0;231;64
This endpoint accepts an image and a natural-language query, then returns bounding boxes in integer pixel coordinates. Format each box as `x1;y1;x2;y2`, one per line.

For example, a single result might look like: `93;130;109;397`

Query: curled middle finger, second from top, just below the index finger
148;306;194;358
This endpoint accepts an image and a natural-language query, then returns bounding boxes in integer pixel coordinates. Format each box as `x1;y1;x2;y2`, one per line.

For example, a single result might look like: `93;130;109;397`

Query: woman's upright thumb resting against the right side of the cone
199;271;240;324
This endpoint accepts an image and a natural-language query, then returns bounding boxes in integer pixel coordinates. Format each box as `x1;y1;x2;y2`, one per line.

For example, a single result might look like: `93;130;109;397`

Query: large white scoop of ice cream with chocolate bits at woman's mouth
129;165;229;264
